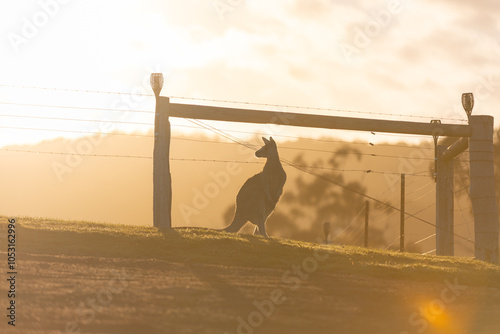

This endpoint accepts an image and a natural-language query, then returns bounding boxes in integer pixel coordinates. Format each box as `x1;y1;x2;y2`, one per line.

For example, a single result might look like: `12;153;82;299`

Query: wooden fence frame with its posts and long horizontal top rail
151;73;499;263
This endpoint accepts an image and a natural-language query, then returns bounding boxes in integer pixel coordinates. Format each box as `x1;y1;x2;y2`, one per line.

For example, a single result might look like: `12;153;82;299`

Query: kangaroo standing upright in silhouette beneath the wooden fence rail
224;137;286;238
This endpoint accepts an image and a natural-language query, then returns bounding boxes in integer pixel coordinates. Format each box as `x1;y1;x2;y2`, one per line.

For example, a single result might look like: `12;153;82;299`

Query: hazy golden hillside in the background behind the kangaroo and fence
0;132;474;256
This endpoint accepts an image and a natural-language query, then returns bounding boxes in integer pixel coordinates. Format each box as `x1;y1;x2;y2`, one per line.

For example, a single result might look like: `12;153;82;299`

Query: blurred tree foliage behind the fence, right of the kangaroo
224;146;391;247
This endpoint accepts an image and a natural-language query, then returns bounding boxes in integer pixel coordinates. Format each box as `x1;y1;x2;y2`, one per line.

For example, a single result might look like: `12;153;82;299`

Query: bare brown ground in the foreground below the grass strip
0;252;500;334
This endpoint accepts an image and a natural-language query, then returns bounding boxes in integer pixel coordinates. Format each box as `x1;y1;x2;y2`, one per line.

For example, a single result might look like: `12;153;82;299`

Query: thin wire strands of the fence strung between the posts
0;85;473;254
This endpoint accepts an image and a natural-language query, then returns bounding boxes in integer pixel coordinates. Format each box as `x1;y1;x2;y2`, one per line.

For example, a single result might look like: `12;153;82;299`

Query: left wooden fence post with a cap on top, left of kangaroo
151;73;172;229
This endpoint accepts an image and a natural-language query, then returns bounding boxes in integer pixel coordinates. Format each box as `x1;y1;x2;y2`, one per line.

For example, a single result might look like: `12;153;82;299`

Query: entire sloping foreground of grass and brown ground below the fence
0;217;500;334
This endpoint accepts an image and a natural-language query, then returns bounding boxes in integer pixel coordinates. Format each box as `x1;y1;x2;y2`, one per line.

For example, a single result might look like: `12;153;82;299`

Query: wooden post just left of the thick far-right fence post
436;145;455;256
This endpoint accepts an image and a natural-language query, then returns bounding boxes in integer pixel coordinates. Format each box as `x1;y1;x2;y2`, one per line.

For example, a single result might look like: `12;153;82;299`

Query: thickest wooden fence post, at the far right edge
469;116;499;263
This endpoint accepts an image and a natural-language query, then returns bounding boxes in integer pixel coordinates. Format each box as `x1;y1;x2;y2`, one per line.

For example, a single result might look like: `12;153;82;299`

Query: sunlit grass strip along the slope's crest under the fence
0;217;500;287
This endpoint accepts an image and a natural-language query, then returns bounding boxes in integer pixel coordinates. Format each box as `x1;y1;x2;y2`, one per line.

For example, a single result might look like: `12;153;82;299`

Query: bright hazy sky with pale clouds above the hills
0;0;500;147
